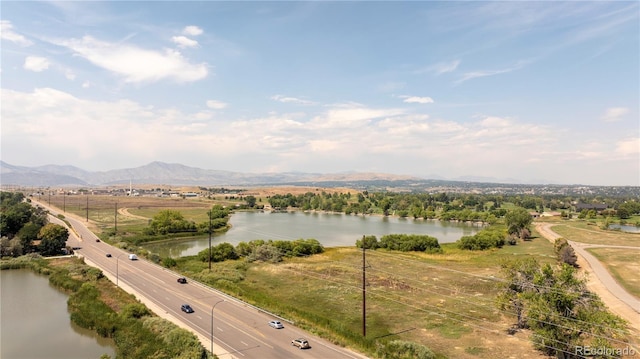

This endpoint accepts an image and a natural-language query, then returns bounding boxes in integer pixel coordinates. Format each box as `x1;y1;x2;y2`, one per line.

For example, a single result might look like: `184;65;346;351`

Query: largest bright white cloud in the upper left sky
57;36;208;83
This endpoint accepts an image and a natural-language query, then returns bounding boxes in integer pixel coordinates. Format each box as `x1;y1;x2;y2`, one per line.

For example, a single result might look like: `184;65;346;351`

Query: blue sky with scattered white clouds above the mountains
0;1;640;186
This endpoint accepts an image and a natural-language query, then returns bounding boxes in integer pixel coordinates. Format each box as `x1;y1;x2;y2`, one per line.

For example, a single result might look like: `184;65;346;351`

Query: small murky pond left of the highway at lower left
0;269;115;359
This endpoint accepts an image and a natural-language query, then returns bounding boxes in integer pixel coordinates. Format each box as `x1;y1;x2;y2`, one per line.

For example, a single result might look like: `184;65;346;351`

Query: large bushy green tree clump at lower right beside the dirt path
497;259;626;359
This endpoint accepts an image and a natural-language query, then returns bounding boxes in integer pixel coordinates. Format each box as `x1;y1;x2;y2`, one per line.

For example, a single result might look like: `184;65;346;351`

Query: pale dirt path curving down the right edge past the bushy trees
534;223;640;338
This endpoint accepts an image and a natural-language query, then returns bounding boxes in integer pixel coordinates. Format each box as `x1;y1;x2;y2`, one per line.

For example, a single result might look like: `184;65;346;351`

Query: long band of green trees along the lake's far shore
262;191;640;223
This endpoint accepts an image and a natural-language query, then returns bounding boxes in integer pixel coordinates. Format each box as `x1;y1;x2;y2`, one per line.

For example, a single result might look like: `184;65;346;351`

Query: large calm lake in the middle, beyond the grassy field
144;211;480;258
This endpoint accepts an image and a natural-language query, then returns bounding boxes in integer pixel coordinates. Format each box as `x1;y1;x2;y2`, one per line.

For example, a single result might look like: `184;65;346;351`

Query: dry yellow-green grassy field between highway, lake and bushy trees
172;239;555;358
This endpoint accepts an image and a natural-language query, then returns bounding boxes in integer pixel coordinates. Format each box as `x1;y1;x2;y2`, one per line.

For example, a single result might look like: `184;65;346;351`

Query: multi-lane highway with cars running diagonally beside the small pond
34;201;366;359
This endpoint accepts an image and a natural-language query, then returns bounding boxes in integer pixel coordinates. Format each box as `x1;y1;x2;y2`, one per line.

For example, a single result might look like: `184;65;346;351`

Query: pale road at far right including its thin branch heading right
536;223;640;331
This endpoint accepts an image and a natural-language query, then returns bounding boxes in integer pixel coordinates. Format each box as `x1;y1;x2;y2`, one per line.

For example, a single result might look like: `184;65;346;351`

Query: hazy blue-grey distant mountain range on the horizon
0;161;420;187
